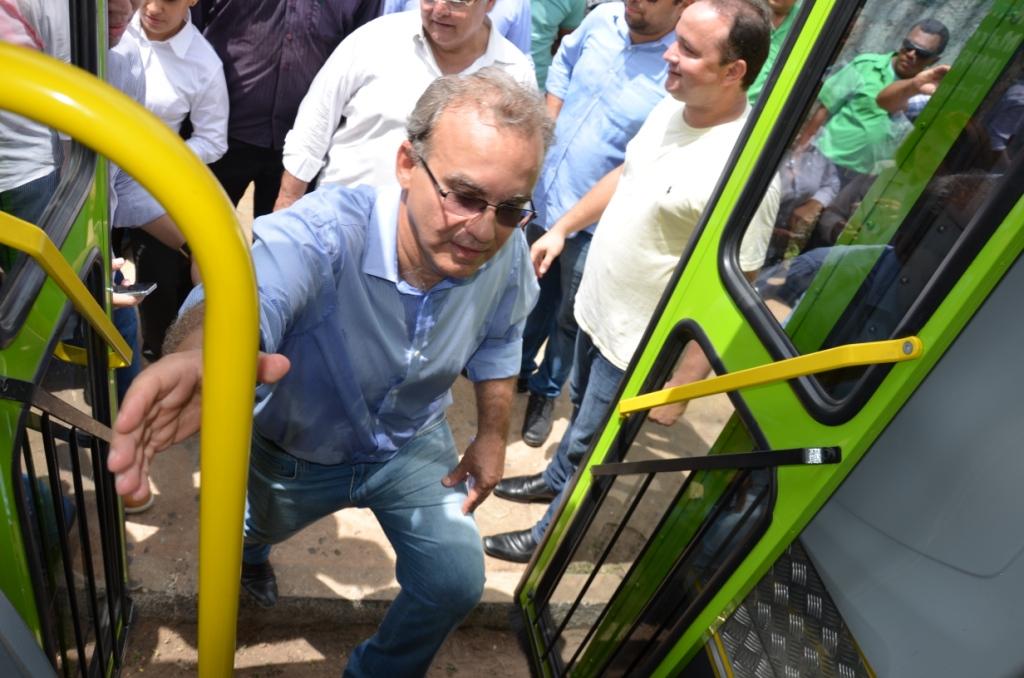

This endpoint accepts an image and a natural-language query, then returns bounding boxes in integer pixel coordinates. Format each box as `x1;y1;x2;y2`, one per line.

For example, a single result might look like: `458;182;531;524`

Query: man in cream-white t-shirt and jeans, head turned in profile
483;0;779;562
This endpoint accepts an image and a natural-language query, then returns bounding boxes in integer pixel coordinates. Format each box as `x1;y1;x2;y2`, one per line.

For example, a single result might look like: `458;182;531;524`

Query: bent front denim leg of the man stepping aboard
345;422;483;678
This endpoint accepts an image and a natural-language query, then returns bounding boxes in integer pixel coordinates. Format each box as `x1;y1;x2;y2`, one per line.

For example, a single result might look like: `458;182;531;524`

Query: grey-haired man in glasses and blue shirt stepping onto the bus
109;69;551;676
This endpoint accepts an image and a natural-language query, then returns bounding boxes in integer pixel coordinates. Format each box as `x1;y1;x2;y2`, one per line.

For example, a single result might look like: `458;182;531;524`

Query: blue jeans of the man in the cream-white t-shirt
530;332;626;542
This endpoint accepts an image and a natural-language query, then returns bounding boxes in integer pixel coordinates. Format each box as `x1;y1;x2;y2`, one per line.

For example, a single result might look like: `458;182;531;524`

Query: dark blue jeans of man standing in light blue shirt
519;223;591;397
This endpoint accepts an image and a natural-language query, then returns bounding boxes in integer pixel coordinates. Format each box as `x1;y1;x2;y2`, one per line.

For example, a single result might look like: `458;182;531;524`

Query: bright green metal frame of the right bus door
516;0;1024;675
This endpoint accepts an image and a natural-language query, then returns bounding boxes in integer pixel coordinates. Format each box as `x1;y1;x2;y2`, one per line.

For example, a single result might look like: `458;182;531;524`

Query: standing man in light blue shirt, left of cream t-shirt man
520;0;689;450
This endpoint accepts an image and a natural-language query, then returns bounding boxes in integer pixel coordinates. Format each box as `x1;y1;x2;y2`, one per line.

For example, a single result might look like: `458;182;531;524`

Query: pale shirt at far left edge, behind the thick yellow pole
0;0;71;193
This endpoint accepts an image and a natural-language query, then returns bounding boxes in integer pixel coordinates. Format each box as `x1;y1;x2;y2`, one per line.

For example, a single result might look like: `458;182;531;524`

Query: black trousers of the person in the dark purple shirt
210;139;285;217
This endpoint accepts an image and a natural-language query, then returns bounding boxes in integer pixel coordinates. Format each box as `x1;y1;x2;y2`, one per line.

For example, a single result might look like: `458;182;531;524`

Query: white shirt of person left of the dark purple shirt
114;12;228;164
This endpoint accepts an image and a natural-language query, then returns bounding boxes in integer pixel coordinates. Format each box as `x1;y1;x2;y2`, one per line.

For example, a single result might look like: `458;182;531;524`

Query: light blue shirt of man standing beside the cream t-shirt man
534;2;675;232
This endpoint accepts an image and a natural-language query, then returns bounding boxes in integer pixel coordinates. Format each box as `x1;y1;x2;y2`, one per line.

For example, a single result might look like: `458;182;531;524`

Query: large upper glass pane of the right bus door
732;0;1024;411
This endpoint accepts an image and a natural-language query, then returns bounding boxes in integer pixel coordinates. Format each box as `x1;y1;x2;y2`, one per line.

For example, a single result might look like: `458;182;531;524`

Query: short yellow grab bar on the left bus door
0;212;131;365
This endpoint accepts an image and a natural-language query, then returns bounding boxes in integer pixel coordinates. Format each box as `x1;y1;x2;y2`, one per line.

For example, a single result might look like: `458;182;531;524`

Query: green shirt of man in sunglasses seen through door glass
815;52;899;174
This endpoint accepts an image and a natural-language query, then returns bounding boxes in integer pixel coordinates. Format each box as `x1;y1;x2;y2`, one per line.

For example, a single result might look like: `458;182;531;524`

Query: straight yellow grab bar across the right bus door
618;337;924;416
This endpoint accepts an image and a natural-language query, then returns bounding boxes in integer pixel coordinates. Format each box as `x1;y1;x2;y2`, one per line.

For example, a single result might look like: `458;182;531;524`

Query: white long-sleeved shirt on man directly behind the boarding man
284;10;537;186
